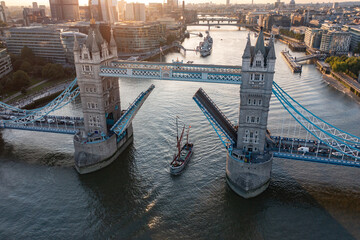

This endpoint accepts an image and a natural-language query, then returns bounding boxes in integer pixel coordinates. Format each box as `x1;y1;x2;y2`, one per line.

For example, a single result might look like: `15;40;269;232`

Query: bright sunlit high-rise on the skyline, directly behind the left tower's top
89;0;118;24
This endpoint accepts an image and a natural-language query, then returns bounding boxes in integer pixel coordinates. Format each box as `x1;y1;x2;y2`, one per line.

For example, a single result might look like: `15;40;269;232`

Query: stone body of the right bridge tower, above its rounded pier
237;32;275;154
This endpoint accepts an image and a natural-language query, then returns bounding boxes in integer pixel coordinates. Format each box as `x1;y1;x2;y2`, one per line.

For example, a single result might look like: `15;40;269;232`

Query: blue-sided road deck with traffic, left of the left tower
0;112;84;135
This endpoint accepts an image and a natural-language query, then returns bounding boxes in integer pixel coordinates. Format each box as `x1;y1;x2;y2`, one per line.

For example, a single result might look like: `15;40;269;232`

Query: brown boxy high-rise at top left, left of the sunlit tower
49;0;80;21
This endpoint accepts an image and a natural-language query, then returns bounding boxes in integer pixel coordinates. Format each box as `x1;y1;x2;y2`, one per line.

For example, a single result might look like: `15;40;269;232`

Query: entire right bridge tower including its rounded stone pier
226;29;276;198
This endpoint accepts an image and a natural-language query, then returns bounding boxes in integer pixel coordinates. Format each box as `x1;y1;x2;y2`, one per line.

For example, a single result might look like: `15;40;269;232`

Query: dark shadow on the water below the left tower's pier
79;144;162;239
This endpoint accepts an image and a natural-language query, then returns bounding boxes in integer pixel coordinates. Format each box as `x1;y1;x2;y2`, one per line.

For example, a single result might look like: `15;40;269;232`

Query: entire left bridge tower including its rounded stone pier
74;22;132;174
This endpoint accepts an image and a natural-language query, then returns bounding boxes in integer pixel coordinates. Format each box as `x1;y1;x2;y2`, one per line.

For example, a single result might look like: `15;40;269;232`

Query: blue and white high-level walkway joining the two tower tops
100;61;241;84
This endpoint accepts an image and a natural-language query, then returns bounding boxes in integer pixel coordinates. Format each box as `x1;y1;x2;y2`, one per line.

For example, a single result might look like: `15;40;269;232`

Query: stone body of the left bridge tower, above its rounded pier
74;26;121;141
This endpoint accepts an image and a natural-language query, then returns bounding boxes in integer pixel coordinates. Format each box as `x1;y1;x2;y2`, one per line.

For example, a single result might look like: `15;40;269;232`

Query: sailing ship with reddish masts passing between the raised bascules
170;118;194;175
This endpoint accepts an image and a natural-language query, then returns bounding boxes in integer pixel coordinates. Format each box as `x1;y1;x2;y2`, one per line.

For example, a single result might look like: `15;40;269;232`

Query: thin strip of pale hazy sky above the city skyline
4;0;358;6
